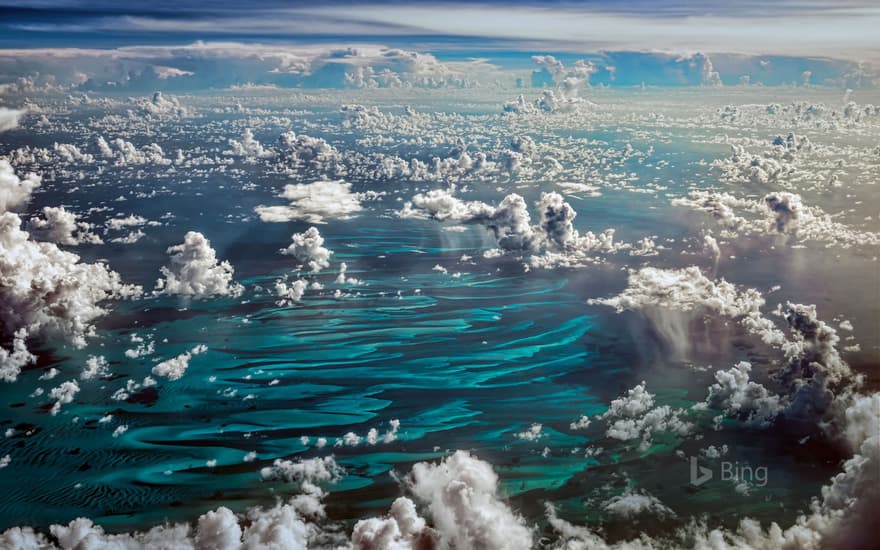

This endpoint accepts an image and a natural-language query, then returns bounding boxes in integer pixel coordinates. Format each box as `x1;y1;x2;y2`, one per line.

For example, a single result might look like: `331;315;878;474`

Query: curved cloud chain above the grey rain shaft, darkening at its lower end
590;267;861;435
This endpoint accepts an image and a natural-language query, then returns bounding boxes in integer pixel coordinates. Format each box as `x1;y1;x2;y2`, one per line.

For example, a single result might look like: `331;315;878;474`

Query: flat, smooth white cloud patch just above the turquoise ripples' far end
255;181;365;223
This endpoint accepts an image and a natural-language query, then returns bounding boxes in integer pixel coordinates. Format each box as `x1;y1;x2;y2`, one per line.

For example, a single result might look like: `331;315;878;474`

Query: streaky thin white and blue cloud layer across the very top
0;1;880;61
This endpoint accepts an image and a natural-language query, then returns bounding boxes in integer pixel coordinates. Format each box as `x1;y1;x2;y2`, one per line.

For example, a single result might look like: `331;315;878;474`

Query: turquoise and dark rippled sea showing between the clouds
0;92;872;532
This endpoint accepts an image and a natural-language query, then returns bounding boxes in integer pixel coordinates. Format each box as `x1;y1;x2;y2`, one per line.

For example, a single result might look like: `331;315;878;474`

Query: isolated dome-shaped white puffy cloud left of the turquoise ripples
156;231;244;298
